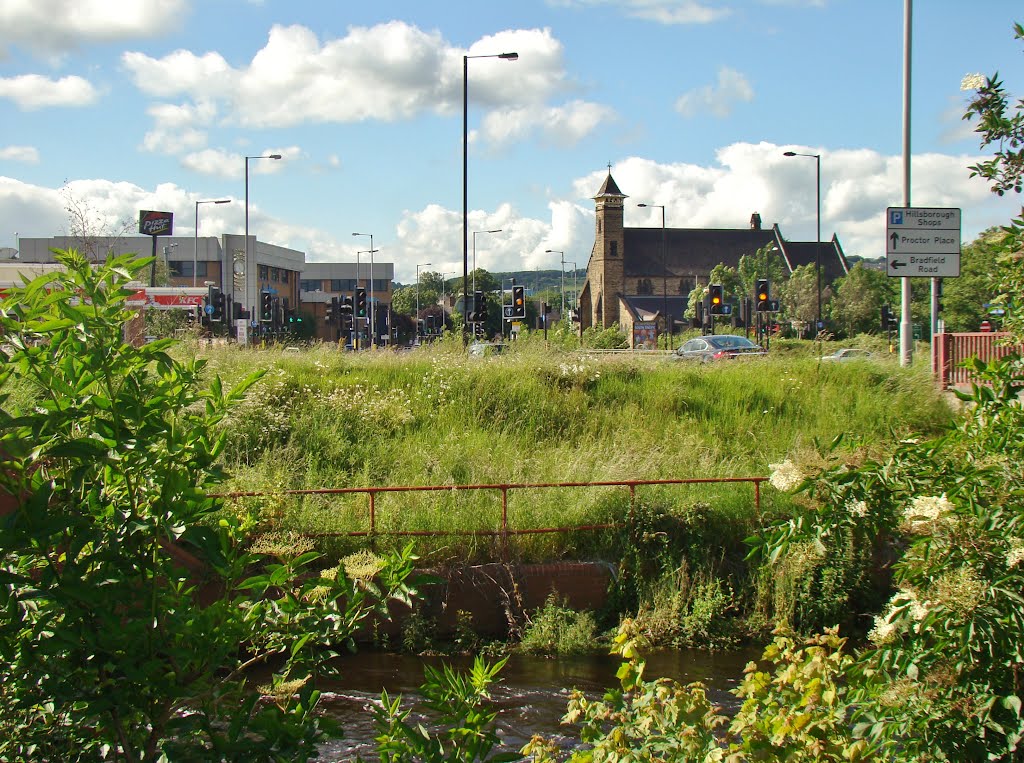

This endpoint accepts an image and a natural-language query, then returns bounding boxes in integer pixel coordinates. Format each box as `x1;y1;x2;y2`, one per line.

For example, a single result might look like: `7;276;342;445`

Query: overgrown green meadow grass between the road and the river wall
190;338;951;561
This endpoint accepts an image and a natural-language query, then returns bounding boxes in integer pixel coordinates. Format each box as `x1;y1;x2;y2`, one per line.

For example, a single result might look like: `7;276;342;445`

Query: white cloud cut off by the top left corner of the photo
0;0;188;55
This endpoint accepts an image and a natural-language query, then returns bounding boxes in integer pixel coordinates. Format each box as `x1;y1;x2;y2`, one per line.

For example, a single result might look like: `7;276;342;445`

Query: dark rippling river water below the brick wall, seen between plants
321;648;760;763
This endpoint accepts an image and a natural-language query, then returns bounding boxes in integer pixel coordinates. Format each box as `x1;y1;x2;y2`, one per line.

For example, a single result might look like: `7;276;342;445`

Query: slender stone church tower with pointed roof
587;166;626;327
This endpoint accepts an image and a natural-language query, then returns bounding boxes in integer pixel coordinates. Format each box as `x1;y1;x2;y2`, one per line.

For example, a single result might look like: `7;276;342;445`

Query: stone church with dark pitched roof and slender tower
580;171;849;347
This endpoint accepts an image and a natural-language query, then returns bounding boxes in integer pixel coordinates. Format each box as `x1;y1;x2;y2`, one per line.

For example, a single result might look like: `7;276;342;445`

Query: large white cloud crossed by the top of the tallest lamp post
122;22;566;127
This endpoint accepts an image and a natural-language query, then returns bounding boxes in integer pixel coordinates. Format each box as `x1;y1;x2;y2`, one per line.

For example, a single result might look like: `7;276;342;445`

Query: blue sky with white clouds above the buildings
0;0;1024;284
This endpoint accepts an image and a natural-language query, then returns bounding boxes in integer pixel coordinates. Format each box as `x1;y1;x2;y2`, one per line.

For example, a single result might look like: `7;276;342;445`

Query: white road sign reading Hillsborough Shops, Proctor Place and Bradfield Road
886;207;961;278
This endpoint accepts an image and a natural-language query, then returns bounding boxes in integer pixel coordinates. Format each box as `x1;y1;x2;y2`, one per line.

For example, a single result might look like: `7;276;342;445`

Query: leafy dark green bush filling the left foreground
0;251;414;762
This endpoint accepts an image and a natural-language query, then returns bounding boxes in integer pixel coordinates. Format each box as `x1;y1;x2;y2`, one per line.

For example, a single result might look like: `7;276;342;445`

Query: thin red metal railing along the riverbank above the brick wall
210;477;767;538
